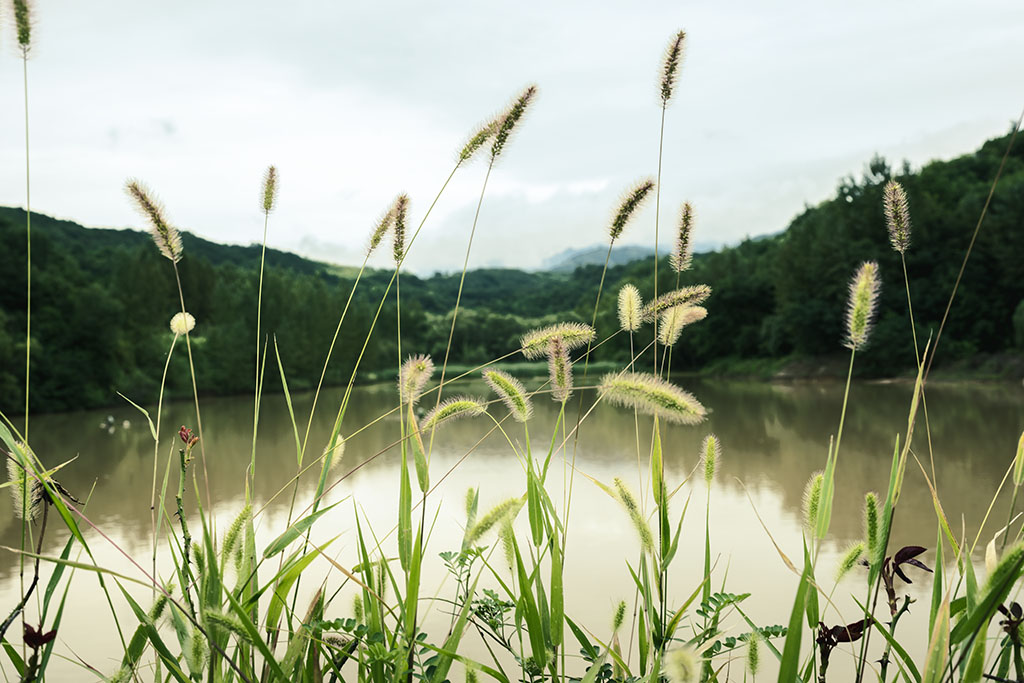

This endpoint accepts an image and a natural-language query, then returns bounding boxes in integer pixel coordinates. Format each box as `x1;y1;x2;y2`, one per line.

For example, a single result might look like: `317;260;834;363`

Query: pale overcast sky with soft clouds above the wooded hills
0;0;1024;272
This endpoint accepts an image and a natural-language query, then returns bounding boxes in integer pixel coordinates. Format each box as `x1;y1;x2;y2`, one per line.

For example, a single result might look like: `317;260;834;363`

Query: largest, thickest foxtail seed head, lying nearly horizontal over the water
600;373;708;425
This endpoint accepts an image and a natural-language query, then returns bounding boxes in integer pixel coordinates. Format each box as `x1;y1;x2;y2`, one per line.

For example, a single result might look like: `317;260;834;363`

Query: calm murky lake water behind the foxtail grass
0;381;1024;681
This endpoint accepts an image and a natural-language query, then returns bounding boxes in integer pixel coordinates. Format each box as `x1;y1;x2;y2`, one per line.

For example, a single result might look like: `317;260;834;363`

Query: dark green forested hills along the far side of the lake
0;131;1024;415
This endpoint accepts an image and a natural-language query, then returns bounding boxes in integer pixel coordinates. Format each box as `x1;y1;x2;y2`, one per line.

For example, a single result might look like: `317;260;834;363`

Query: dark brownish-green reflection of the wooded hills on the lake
0;380;1024;571
